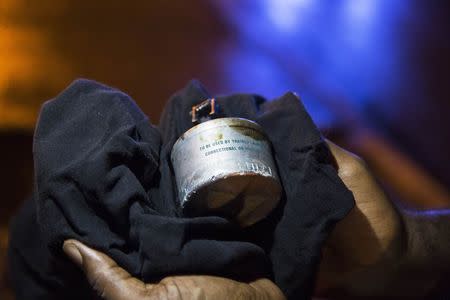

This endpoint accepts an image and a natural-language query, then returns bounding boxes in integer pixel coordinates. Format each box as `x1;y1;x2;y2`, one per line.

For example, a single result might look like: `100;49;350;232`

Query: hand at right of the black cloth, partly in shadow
318;142;405;295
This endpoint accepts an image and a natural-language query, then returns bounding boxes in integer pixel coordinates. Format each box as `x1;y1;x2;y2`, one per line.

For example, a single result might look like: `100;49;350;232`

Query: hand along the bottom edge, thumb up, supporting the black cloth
63;240;285;300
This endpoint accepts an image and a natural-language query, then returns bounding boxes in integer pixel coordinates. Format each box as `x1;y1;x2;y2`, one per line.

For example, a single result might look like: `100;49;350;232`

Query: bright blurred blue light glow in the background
215;0;408;123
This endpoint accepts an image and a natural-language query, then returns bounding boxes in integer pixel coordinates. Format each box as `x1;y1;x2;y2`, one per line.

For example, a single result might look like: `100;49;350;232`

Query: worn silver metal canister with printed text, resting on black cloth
171;118;281;227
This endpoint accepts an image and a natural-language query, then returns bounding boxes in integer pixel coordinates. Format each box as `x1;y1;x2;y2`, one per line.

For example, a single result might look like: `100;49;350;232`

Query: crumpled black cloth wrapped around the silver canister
9;80;354;299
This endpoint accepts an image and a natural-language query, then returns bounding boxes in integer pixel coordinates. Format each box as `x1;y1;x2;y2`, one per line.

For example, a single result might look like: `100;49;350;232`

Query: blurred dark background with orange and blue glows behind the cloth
0;0;450;299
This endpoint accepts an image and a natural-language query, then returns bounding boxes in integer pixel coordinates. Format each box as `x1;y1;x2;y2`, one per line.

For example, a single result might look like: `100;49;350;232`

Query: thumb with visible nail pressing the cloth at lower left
63;239;149;300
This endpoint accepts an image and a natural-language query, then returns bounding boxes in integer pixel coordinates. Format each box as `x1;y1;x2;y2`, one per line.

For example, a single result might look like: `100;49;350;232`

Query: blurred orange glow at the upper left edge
0;0;72;128
